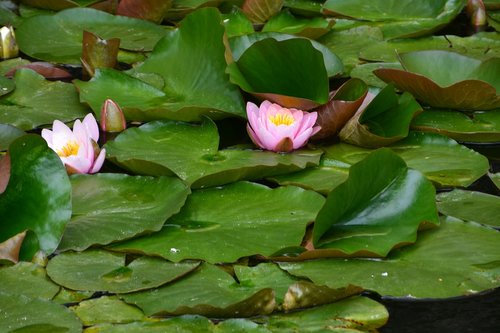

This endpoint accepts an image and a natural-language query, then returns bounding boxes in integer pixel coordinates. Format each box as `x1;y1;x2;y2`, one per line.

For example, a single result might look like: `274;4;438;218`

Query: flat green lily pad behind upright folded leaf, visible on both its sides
272;132;489;194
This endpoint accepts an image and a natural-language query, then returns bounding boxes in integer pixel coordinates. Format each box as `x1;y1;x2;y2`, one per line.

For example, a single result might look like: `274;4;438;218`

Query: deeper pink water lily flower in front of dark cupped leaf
247;101;321;152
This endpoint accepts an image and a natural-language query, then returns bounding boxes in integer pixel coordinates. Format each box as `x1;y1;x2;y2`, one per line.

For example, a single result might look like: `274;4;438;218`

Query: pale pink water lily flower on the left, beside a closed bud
42;113;106;174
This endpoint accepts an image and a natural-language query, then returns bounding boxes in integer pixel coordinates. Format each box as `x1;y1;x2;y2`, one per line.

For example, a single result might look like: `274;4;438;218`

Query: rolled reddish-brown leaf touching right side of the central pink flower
314;79;368;139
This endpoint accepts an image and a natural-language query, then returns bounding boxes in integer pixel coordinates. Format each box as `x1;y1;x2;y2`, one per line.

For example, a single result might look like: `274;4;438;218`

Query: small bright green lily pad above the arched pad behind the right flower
262;10;335;39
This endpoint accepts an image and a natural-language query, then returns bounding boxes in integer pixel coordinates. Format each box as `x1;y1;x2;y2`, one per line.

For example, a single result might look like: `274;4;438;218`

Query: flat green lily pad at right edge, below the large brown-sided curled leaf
411;109;500;142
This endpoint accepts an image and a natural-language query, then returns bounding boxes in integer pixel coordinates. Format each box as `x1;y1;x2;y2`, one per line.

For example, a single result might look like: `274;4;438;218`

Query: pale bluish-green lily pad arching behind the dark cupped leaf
229;32;344;77
